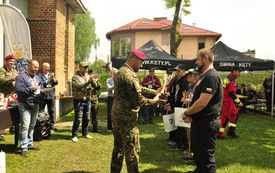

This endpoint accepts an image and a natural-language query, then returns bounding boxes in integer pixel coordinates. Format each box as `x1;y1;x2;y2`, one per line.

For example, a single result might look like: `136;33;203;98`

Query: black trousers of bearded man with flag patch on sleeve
191;118;221;173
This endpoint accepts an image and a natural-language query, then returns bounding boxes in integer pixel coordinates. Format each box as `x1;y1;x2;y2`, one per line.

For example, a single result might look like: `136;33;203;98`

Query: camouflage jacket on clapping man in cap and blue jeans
72;71;93;100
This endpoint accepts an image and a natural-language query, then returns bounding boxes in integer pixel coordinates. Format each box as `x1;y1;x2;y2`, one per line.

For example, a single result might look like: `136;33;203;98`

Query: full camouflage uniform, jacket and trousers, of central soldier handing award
111;65;155;173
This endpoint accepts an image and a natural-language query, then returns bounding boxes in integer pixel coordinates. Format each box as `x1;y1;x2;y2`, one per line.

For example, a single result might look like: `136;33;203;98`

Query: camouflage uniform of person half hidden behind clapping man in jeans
91;81;101;132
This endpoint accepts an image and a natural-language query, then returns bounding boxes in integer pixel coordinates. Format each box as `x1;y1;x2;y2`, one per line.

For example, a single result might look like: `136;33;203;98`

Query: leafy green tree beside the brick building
75;10;100;62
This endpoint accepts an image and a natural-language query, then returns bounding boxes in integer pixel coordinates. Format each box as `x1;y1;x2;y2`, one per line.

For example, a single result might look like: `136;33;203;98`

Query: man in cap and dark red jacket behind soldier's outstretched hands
141;68;161;124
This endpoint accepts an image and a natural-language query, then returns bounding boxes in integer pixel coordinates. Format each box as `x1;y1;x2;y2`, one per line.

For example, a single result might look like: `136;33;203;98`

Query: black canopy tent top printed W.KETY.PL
112;40;195;70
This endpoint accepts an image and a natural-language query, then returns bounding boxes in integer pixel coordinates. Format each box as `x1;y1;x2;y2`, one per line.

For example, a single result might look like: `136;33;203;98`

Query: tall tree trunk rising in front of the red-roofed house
164;0;191;57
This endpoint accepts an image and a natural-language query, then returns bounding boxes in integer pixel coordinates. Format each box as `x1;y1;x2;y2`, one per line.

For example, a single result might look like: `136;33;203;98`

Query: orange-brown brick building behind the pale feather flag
0;0;86;117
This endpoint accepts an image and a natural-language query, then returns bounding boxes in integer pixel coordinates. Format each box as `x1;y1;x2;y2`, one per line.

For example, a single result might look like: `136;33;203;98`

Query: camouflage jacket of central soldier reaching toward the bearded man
112;65;156;122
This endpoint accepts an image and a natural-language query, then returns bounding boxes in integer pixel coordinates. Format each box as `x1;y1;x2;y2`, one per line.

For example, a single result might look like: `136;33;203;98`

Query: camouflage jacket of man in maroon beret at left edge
0;66;18;97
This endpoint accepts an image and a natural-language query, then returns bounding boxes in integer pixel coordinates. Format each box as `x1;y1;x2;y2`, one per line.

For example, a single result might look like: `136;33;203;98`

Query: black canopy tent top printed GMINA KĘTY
211;41;274;71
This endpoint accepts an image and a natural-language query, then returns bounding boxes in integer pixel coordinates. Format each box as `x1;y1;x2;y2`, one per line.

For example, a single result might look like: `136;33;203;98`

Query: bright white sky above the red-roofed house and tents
81;0;275;62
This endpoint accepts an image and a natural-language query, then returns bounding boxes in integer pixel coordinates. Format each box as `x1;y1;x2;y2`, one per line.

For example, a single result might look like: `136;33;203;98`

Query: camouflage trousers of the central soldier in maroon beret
111;118;140;173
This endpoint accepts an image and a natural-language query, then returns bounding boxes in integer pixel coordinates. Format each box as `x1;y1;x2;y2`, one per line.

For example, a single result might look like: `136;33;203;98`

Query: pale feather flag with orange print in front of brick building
0;4;32;72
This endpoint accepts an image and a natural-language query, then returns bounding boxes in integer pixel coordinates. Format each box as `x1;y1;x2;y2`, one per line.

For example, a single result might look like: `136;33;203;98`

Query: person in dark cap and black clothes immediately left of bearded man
165;64;188;152
